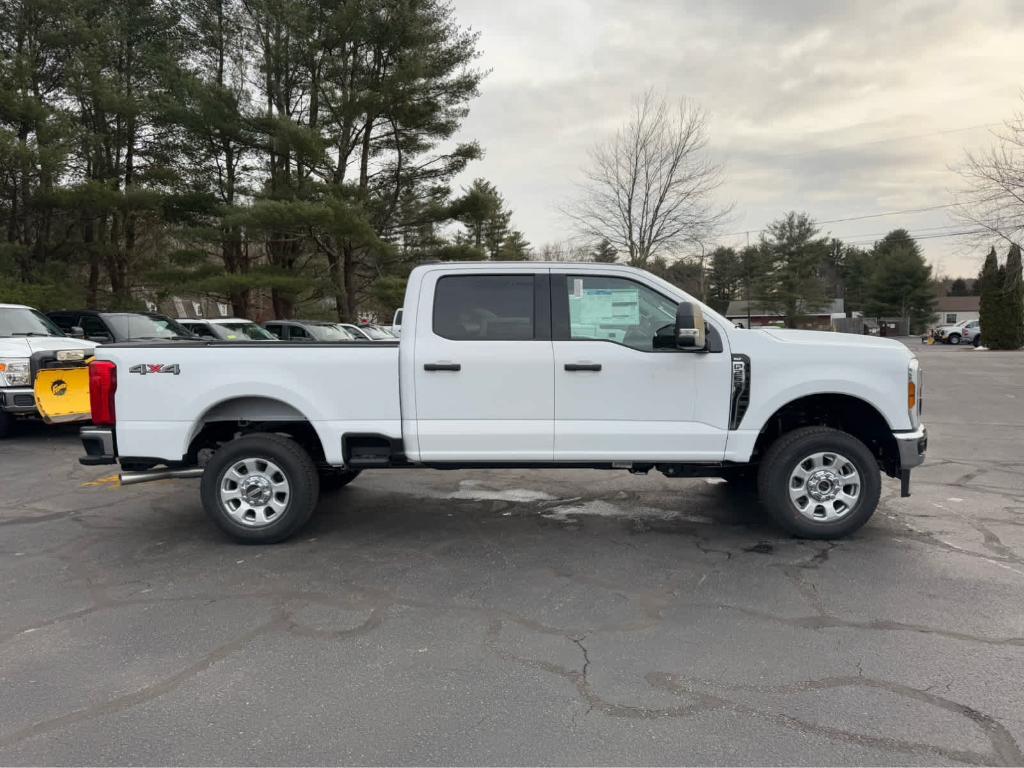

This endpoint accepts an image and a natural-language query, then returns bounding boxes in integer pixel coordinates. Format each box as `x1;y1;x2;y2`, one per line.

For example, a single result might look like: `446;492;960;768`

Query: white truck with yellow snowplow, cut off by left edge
0;304;95;437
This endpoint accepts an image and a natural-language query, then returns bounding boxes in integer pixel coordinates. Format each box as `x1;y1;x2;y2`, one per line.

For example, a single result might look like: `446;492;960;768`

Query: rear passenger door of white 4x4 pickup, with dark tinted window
402;267;554;463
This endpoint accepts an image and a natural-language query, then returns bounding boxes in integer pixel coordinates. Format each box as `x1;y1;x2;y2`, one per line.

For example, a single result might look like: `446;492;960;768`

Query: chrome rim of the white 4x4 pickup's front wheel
788;451;861;522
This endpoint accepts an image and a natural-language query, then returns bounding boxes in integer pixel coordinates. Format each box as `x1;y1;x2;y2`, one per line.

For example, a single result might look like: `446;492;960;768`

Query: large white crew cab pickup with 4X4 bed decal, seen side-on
82;262;927;543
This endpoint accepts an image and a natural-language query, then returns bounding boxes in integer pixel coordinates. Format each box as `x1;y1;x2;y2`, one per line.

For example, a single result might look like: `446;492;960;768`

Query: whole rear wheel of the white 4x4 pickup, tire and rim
200;434;319;544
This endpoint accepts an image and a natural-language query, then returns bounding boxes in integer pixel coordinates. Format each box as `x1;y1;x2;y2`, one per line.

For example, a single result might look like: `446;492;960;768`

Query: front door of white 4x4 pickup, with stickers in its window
551;270;731;462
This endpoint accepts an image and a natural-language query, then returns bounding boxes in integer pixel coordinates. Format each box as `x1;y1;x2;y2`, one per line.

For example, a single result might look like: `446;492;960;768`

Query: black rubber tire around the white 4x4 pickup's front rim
758;427;882;539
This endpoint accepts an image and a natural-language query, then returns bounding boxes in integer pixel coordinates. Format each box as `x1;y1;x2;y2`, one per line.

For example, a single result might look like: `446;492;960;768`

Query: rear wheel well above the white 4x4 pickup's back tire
183;397;326;464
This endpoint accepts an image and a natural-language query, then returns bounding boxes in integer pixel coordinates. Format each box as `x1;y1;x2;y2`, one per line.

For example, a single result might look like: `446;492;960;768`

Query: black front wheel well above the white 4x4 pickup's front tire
751;393;899;477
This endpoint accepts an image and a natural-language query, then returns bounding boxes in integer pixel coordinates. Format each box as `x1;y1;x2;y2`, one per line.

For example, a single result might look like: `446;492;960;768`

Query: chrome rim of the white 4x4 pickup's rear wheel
220;458;292;528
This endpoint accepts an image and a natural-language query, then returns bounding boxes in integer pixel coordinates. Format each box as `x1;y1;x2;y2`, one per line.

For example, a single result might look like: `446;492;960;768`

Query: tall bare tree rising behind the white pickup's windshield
565;91;728;266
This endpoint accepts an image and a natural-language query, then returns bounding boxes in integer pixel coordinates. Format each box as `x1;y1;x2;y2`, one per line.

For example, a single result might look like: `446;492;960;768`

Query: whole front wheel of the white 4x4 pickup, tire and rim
758;427;882;539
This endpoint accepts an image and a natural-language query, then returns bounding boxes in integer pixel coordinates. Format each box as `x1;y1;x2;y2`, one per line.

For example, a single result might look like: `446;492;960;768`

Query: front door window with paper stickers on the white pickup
565;274;676;352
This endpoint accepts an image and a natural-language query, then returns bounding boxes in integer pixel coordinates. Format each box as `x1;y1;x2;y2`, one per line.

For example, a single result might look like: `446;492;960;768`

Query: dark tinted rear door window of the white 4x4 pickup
433;274;535;341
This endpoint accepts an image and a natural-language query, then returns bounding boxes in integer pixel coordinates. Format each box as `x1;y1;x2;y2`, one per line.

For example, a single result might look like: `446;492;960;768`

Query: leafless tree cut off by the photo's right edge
954;92;1024;244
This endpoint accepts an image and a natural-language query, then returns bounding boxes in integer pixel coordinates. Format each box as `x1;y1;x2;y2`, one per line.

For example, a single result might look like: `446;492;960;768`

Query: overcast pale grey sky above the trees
455;0;1024;274
